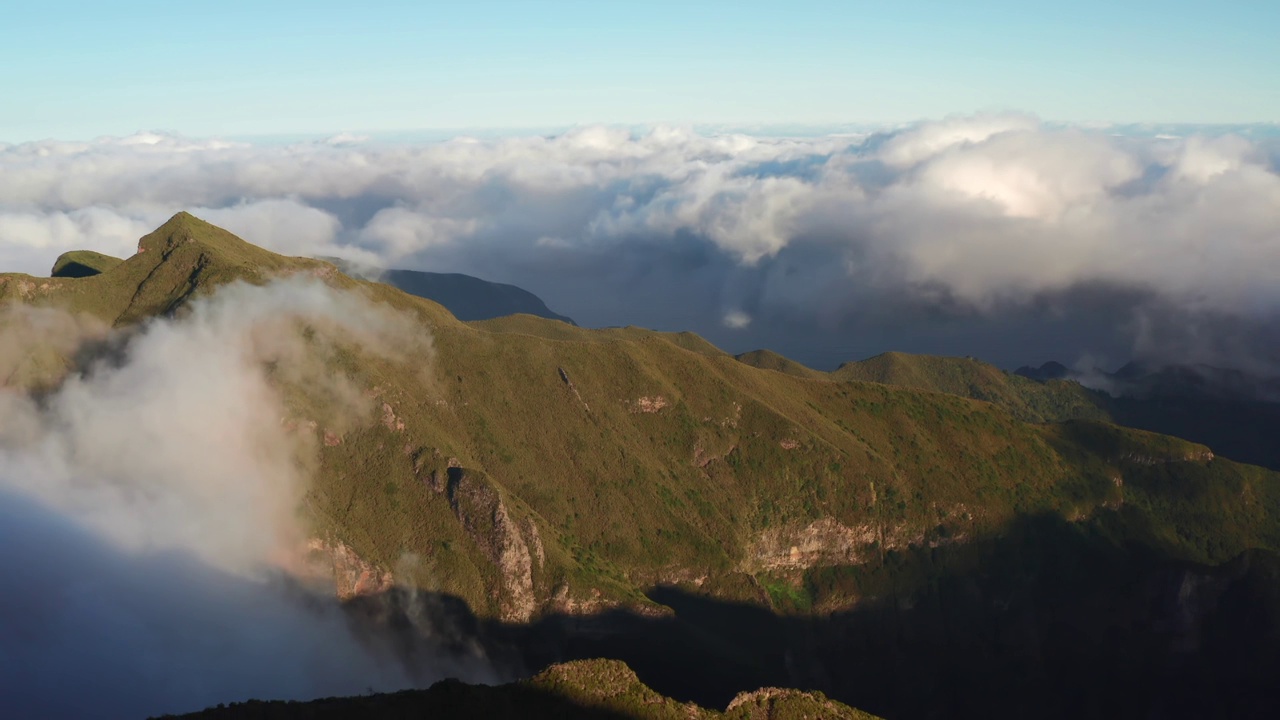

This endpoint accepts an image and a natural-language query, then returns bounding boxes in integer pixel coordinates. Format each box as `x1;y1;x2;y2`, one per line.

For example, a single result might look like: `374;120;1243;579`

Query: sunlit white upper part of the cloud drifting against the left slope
0;281;426;571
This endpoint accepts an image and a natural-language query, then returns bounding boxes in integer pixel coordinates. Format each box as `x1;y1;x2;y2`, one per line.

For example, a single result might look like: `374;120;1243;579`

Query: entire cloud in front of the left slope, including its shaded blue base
0;281;490;717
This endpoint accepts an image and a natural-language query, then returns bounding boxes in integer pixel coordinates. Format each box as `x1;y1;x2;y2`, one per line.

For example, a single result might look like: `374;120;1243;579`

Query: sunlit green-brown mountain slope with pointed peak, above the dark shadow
10;208;1277;609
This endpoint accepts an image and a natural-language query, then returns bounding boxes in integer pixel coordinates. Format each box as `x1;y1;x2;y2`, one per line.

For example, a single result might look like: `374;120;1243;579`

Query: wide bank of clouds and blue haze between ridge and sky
0;115;1280;369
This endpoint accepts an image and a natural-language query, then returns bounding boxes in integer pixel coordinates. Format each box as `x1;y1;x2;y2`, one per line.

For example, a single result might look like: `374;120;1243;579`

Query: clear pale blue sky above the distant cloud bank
0;0;1280;142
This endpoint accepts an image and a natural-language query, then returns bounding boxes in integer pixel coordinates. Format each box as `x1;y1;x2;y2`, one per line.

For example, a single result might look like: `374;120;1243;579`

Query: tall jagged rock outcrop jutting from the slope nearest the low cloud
447;468;543;623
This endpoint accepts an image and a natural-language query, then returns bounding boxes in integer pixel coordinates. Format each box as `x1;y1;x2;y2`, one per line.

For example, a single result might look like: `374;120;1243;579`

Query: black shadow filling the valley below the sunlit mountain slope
348;510;1280;719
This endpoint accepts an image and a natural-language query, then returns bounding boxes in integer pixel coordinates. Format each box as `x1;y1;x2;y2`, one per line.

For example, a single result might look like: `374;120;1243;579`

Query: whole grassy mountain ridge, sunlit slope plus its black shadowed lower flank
0;213;1280;717
